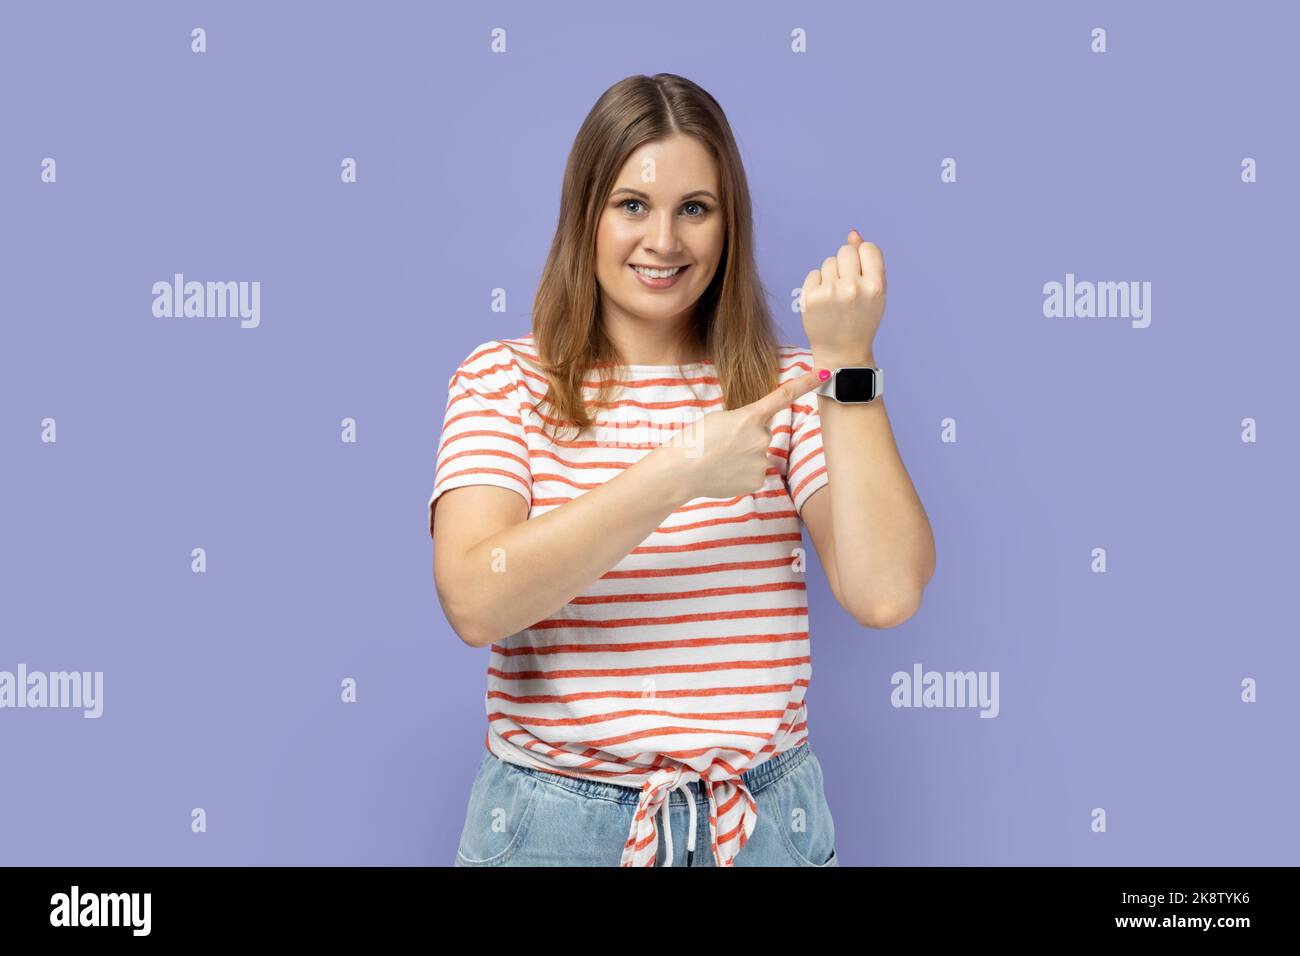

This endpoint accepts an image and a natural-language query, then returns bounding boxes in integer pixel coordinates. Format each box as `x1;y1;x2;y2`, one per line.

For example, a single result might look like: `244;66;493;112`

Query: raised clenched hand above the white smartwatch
802;229;885;356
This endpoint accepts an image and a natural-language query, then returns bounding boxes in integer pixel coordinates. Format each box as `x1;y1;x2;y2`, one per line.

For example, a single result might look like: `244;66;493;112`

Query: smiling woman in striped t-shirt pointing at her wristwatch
429;74;933;866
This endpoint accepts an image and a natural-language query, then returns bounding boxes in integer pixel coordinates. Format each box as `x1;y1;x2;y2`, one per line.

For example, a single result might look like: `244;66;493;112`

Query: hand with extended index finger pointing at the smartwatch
671;369;822;501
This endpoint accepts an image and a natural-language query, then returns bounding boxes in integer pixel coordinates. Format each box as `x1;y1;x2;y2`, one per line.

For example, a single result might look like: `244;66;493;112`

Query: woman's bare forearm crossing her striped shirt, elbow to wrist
456;445;692;646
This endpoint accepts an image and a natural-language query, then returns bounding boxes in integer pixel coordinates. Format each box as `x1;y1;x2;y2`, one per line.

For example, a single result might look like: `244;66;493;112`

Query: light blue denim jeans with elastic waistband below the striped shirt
455;743;840;866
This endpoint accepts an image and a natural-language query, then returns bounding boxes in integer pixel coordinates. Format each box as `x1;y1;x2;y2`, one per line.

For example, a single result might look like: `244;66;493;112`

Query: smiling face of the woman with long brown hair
595;133;725;356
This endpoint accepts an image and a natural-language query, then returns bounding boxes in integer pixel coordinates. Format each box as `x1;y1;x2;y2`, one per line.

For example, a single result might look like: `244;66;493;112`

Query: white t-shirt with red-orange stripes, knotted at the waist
429;333;828;866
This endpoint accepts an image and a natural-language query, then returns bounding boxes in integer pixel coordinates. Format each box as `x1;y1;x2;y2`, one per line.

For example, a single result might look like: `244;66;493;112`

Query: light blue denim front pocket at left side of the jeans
455;754;540;866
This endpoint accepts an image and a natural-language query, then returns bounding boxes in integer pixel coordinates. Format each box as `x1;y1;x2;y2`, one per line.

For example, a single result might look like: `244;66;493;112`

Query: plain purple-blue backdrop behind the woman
0;3;1300;865
